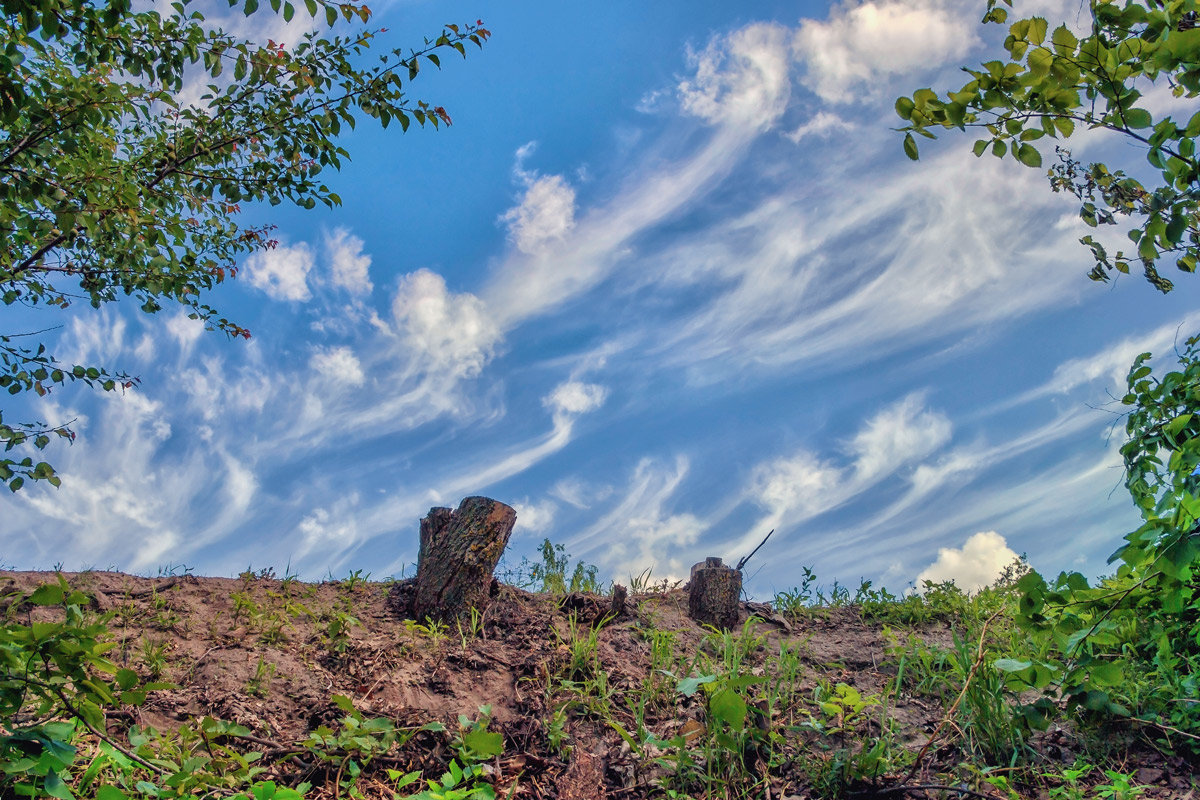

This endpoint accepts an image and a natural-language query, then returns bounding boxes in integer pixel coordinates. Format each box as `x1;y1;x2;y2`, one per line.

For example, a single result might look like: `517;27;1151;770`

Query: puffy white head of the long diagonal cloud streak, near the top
678;23;791;130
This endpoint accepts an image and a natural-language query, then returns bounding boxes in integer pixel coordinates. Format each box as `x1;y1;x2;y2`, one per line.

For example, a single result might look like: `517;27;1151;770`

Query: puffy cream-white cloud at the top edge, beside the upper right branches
794;0;978;103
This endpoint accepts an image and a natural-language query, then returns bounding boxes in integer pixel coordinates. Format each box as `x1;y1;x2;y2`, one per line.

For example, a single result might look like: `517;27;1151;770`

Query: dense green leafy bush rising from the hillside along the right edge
997;338;1200;753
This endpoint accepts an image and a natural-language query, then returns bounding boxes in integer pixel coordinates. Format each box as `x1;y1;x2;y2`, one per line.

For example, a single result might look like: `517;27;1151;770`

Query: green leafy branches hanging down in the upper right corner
895;0;1200;291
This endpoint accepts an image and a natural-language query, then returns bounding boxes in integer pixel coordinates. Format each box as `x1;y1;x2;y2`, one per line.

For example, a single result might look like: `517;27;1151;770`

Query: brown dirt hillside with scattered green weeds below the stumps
0;571;1200;800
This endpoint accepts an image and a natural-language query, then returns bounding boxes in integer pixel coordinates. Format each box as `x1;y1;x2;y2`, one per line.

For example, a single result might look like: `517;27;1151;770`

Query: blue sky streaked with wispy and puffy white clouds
0;0;1200;597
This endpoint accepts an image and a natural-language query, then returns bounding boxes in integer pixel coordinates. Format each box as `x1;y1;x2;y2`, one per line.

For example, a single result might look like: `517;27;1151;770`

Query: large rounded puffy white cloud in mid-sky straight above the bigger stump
391;269;500;378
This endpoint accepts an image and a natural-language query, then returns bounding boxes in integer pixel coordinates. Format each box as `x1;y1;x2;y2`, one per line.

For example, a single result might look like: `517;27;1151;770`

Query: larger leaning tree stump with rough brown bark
412;497;517;621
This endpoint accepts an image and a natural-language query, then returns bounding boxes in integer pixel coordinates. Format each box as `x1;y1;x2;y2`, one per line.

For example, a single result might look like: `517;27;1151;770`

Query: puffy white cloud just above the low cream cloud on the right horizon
851;395;952;479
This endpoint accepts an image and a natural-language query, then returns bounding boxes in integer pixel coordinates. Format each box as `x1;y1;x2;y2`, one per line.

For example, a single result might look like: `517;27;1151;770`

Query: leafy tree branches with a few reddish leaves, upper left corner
0;0;490;491
